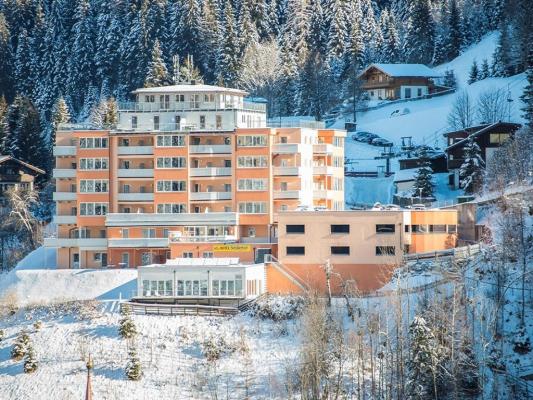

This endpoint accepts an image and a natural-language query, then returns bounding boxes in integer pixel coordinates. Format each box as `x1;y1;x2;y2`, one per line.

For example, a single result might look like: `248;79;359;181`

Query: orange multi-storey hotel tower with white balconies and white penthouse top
45;84;345;268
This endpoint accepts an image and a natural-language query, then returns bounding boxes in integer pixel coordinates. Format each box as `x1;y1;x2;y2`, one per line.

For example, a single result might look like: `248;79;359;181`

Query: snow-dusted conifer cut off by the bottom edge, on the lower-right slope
405;316;442;400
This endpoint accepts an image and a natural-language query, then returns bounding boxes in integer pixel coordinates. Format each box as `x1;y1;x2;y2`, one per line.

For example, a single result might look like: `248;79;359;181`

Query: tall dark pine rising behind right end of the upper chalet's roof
404;0;435;64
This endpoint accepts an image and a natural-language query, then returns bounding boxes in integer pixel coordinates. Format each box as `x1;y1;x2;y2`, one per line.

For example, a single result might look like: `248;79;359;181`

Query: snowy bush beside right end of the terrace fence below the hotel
250;296;305;321
